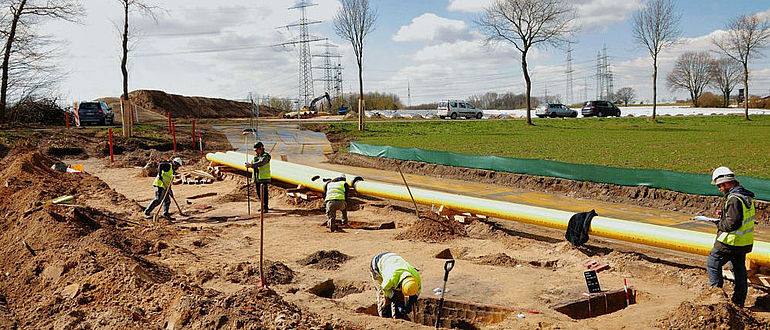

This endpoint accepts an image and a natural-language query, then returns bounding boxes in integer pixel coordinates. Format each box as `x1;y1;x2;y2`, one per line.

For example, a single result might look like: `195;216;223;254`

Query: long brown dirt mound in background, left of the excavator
99;90;280;118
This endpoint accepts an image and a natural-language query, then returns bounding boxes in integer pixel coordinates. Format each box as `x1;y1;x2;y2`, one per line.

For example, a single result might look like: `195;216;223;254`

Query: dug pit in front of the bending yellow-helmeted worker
356;296;514;329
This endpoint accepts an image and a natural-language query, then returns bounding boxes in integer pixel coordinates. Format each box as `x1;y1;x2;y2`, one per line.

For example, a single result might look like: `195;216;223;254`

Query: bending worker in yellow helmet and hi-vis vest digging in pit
371;252;422;319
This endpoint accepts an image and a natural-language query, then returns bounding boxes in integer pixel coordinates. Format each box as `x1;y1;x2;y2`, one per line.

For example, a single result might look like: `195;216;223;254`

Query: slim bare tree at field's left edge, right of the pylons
334;0;377;131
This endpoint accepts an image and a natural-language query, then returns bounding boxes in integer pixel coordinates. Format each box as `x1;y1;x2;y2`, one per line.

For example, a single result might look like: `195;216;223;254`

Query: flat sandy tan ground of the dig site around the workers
75;159;770;329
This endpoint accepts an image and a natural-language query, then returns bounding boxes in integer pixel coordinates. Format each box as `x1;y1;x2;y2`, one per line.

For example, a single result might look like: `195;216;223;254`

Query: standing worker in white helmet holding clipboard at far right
706;167;756;307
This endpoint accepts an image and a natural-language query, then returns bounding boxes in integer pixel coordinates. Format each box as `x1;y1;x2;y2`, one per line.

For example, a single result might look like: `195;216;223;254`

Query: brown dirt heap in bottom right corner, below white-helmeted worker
659;287;770;329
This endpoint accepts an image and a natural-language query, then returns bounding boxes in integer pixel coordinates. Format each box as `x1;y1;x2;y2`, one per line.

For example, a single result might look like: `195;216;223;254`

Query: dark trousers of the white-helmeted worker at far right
706;247;748;306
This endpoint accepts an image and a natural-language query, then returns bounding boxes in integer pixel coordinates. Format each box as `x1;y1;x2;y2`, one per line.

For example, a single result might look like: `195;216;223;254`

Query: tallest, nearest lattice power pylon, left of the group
278;0;326;107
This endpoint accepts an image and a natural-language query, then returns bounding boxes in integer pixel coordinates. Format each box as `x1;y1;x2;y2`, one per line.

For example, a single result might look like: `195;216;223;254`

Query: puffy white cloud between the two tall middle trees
393;13;473;42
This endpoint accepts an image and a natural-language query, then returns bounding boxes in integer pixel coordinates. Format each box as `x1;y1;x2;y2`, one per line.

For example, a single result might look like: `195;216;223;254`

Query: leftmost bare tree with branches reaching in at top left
0;0;82;122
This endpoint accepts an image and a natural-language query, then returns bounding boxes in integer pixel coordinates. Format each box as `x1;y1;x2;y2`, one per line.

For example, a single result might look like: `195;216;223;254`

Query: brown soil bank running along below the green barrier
327;153;770;227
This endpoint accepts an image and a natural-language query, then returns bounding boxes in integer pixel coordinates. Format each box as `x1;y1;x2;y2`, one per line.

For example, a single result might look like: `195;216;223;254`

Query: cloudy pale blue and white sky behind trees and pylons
42;0;770;105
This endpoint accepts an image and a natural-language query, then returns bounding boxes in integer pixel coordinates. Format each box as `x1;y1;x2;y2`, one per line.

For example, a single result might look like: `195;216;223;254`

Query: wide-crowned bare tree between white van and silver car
476;0;577;125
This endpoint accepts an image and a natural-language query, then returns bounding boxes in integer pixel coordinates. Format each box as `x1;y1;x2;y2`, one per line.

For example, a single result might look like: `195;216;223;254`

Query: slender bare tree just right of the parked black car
632;0;681;121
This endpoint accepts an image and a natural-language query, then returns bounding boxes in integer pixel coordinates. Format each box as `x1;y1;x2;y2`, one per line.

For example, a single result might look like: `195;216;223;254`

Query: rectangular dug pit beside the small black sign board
551;288;637;320
